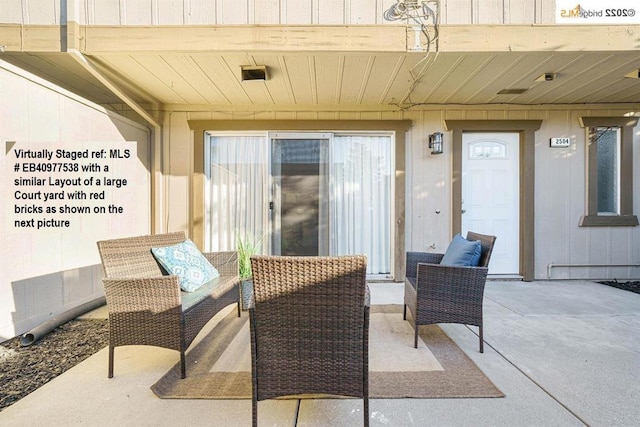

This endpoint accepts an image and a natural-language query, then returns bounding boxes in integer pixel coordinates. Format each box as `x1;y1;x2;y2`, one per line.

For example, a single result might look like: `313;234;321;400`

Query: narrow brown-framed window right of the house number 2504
580;117;638;227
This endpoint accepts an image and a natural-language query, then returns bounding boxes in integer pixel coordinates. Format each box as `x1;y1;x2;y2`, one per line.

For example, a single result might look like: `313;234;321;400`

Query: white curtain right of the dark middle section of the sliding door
330;135;392;274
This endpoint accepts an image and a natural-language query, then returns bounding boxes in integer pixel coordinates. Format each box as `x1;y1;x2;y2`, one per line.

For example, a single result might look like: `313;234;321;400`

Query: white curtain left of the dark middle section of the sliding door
206;135;269;251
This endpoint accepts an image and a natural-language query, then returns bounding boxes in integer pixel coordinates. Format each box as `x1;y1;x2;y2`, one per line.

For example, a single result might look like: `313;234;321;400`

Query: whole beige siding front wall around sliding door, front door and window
165;107;640;279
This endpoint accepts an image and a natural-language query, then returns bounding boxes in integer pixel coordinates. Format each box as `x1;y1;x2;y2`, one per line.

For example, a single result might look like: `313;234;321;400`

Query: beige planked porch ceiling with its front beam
0;26;640;111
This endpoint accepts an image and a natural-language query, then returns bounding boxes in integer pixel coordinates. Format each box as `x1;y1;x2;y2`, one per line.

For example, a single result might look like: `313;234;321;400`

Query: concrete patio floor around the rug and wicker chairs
0;281;640;427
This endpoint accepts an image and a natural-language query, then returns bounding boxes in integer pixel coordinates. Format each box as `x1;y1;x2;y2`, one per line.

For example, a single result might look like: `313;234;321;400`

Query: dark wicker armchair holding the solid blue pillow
404;232;496;353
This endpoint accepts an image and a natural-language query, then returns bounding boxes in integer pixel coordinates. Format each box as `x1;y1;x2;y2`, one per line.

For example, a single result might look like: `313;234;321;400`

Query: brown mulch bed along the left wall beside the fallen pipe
0;319;109;411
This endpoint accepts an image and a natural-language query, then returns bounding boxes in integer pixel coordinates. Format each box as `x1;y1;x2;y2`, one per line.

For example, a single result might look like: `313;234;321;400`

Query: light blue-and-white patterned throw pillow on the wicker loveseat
151;239;220;292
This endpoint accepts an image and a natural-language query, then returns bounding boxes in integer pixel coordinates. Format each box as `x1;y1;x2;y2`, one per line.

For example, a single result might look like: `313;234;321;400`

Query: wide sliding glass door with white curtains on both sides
205;133;394;276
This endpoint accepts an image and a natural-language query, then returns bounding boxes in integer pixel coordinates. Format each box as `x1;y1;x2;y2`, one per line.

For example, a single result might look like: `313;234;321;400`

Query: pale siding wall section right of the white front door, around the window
536;109;640;278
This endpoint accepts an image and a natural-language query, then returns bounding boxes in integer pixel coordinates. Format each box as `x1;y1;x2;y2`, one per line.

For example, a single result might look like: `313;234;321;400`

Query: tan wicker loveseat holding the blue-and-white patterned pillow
98;232;240;378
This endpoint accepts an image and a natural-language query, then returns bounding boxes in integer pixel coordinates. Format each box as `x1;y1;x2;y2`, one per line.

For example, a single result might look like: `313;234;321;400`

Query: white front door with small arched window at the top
462;132;520;275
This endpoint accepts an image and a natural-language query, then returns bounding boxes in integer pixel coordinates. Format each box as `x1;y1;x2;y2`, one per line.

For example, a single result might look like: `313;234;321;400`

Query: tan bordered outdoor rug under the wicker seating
151;305;504;399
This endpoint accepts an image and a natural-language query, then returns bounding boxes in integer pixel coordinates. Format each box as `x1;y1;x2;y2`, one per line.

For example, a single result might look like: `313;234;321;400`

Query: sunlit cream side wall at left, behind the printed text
0;62;150;341
